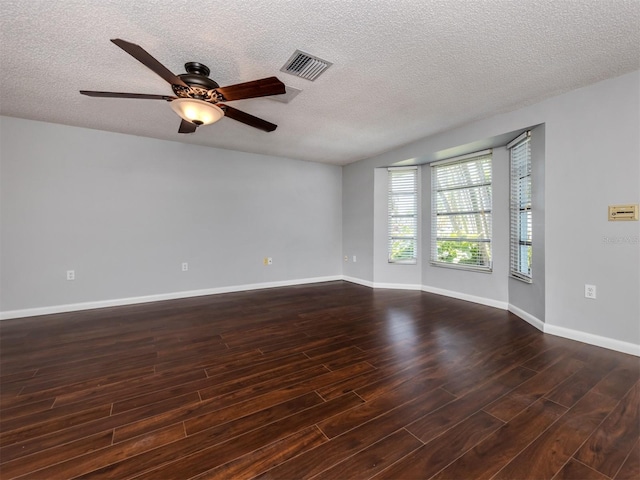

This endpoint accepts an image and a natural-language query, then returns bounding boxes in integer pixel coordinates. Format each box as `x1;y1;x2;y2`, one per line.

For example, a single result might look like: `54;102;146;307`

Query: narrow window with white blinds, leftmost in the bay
388;167;418;264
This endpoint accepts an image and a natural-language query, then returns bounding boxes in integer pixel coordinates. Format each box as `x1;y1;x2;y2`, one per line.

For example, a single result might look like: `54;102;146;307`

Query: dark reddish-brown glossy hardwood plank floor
0;282;640;480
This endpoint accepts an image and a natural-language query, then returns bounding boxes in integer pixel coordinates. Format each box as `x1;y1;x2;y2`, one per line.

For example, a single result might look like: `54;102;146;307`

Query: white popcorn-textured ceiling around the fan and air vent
0;0;640;165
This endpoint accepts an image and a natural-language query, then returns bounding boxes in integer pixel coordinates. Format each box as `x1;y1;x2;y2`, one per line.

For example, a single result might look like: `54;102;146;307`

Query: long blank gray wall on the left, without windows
0;117;342;312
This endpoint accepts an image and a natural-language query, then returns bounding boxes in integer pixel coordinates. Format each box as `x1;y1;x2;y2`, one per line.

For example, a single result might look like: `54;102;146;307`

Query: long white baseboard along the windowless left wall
0;275;342;320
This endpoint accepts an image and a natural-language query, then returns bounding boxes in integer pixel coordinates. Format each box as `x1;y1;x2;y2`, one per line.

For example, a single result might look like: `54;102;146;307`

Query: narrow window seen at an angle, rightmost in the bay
507;132;533;283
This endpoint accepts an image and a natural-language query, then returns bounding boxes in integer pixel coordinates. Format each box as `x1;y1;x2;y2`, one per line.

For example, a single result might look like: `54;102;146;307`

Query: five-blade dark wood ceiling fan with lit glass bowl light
80;38;286;133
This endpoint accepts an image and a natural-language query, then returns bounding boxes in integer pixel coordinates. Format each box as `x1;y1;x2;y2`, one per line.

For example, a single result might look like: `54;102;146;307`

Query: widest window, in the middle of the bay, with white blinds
431;150;492;272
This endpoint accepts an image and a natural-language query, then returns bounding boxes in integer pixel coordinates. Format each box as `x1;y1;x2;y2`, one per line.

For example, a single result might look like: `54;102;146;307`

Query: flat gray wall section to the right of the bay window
545;72;640;344
